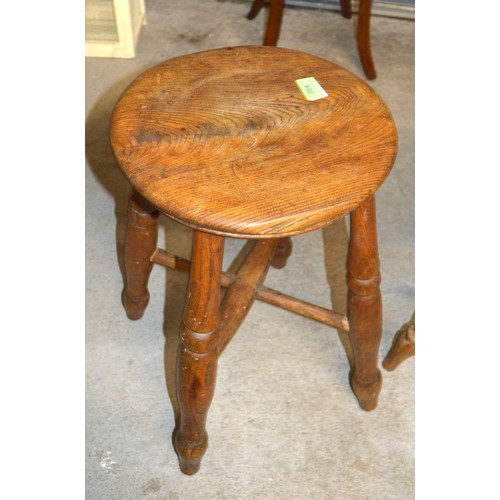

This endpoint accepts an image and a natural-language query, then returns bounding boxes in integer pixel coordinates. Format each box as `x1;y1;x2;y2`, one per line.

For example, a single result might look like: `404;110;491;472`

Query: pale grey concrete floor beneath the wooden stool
86;0;415;500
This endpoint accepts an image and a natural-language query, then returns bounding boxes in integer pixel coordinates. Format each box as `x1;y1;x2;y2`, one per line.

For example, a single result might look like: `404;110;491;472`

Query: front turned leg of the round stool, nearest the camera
174;231;224;475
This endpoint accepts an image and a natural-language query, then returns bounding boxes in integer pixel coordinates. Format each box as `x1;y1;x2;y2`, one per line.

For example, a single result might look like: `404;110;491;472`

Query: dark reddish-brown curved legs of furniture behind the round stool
247;0;377;80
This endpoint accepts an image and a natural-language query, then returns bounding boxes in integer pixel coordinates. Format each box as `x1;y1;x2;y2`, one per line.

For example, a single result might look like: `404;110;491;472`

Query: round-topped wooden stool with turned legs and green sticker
111;47;397;474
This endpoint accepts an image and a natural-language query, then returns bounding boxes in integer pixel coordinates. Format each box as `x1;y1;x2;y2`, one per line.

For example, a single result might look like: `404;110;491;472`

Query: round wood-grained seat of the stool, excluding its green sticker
111;46;397;238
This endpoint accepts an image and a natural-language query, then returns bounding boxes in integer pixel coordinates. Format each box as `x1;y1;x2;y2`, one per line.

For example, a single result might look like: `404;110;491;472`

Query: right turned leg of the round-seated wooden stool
347;196;382;411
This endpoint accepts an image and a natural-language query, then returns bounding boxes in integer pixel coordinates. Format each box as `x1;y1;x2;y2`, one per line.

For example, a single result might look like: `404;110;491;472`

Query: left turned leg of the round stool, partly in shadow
122;191;159;319
